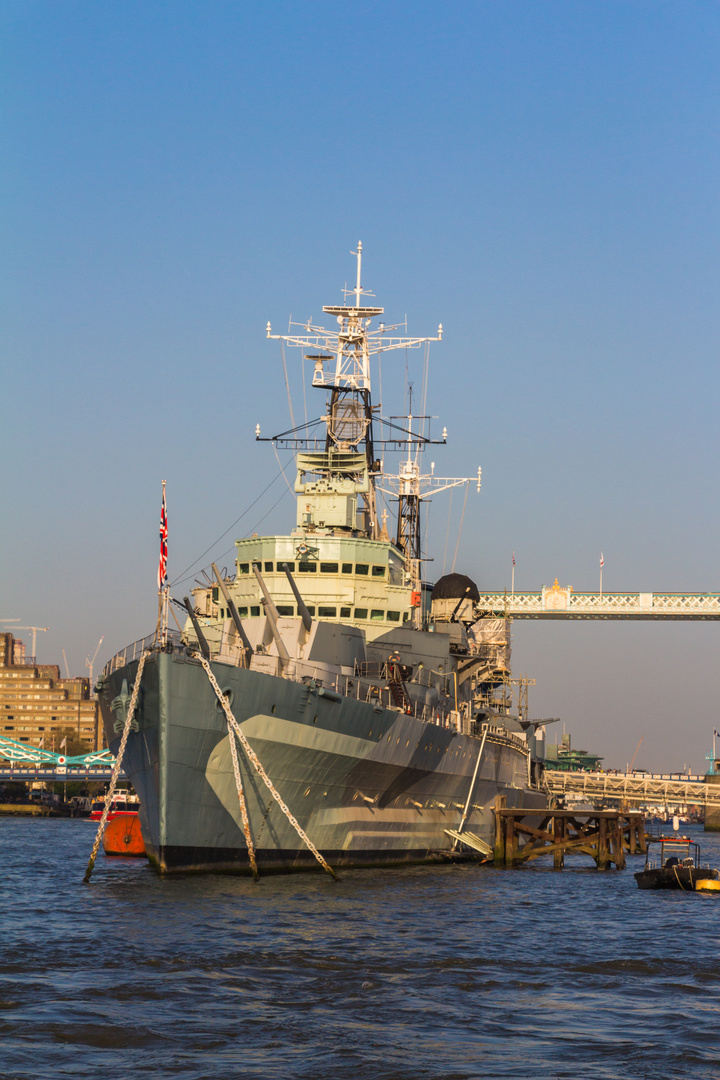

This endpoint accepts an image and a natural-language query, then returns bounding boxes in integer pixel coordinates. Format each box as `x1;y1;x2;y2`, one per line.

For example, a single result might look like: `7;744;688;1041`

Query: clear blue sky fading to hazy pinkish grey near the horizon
0;0;720;769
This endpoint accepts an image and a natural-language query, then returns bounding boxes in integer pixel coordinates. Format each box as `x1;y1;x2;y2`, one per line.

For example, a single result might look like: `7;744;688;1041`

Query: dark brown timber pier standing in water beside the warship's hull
494;795;647;870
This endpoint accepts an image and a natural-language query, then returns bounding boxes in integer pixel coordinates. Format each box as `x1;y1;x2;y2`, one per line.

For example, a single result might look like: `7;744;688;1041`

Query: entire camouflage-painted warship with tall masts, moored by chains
96;245;547;874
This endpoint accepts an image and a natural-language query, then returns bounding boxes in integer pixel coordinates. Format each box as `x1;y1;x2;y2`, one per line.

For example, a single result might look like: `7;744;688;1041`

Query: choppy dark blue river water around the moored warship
0;818;720;1080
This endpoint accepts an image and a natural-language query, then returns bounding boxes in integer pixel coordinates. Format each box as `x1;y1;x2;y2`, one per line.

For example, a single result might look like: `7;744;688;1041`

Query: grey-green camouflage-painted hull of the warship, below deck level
100;652;545;873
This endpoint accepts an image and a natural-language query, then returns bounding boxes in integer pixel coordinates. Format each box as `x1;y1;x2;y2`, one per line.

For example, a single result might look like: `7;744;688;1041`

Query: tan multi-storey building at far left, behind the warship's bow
0;633;101;753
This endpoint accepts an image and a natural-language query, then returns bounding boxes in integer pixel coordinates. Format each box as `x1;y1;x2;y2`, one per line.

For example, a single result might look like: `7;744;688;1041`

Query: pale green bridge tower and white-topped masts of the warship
193;244;480;640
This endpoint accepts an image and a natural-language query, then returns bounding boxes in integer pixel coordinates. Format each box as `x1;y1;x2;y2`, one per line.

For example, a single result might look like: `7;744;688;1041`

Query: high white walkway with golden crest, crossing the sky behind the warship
475;581;720;622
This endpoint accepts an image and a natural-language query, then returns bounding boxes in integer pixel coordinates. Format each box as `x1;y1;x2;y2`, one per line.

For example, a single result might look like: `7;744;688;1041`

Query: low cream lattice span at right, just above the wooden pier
545;769;720;807
